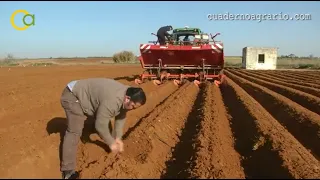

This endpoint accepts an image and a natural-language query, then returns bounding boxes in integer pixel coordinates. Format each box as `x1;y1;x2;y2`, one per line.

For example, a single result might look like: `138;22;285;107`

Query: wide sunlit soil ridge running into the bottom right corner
222;77;320;179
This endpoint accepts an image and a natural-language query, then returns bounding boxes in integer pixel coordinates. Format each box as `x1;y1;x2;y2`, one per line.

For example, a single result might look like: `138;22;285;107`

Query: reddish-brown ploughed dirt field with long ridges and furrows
0;65;320;178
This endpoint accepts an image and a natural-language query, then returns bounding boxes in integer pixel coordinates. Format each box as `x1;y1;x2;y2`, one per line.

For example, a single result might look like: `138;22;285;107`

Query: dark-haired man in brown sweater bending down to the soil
61;78;146;179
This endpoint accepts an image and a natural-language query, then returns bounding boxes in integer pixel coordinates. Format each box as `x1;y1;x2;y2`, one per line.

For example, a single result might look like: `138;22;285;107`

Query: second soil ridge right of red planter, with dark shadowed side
225;72;320;160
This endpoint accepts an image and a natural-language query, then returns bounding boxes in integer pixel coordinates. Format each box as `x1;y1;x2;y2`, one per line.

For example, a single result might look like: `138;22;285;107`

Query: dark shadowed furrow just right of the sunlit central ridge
221;80;291;179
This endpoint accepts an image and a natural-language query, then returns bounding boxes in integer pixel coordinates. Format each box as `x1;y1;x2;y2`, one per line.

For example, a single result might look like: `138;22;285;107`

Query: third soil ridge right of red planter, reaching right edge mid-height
225;70;320;114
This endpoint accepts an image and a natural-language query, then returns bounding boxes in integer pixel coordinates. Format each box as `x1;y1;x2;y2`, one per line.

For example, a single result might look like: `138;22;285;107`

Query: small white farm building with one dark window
242;47;278;70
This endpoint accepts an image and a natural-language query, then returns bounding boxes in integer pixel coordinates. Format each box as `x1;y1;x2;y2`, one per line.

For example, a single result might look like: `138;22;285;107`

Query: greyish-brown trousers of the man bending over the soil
60;87;87;171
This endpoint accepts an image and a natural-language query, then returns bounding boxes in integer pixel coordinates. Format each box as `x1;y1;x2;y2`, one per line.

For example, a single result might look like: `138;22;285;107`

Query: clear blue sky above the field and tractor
0;1;320;58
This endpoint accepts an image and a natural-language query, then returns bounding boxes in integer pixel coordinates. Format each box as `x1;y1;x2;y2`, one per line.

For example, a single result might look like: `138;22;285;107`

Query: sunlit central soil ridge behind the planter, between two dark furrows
189;83;245;179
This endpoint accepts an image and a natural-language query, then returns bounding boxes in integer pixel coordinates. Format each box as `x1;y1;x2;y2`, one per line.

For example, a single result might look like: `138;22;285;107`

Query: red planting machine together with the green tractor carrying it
135;27;224;86
